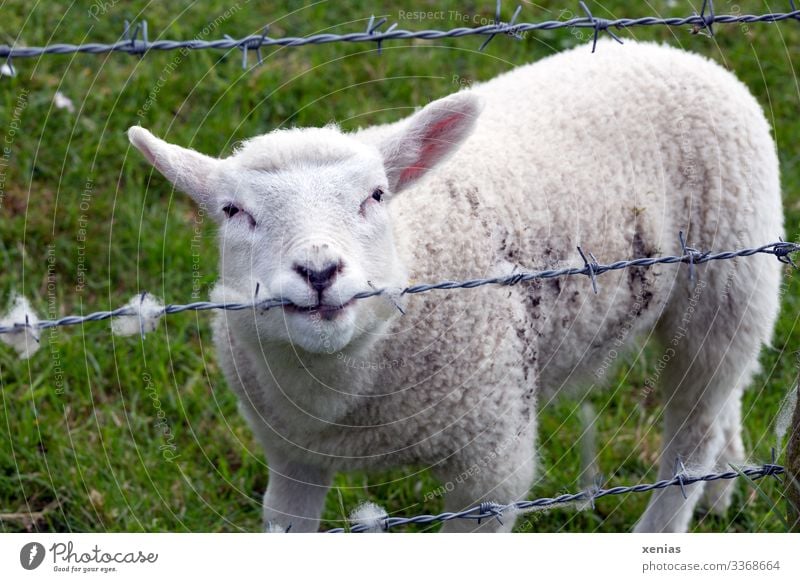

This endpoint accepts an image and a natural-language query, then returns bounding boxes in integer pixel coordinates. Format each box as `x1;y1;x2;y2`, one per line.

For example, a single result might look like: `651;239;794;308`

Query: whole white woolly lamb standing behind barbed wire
129;41;783;532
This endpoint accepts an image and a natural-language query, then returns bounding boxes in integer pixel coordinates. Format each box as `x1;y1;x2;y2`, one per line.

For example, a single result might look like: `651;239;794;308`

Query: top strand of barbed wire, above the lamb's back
0;0;800;68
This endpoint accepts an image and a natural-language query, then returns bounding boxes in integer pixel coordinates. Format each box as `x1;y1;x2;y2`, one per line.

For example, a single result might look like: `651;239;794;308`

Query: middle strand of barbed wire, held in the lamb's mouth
0;232;800;334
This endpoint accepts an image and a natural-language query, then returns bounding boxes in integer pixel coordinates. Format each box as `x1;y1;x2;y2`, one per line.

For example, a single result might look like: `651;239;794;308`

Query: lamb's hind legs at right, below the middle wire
636;262;775;532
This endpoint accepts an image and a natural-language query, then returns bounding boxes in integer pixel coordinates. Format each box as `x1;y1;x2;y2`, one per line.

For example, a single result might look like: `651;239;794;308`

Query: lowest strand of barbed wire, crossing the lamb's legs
327;458;785;533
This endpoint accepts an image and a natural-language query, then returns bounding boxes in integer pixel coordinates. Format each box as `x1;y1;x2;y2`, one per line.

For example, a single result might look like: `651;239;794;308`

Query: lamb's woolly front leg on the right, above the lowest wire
437;423;535;533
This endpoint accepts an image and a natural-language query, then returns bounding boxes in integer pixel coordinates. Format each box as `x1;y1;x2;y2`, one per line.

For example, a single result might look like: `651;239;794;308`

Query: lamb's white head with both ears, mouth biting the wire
128;93;478;353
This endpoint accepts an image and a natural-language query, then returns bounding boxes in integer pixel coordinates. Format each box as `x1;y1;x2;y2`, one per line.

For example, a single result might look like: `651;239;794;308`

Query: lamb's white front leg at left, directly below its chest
264;458;332;532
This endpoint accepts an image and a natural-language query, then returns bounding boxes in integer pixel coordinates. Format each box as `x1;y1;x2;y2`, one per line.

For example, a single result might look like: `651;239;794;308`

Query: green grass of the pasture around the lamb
0;0;800;532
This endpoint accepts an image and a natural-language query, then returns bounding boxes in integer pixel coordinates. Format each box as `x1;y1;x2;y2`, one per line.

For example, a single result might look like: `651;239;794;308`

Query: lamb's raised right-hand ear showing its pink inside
379;91;480;192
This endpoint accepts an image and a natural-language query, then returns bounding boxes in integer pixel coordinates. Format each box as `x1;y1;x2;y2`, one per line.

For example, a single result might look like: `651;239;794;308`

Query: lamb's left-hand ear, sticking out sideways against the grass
128;126;220;203
